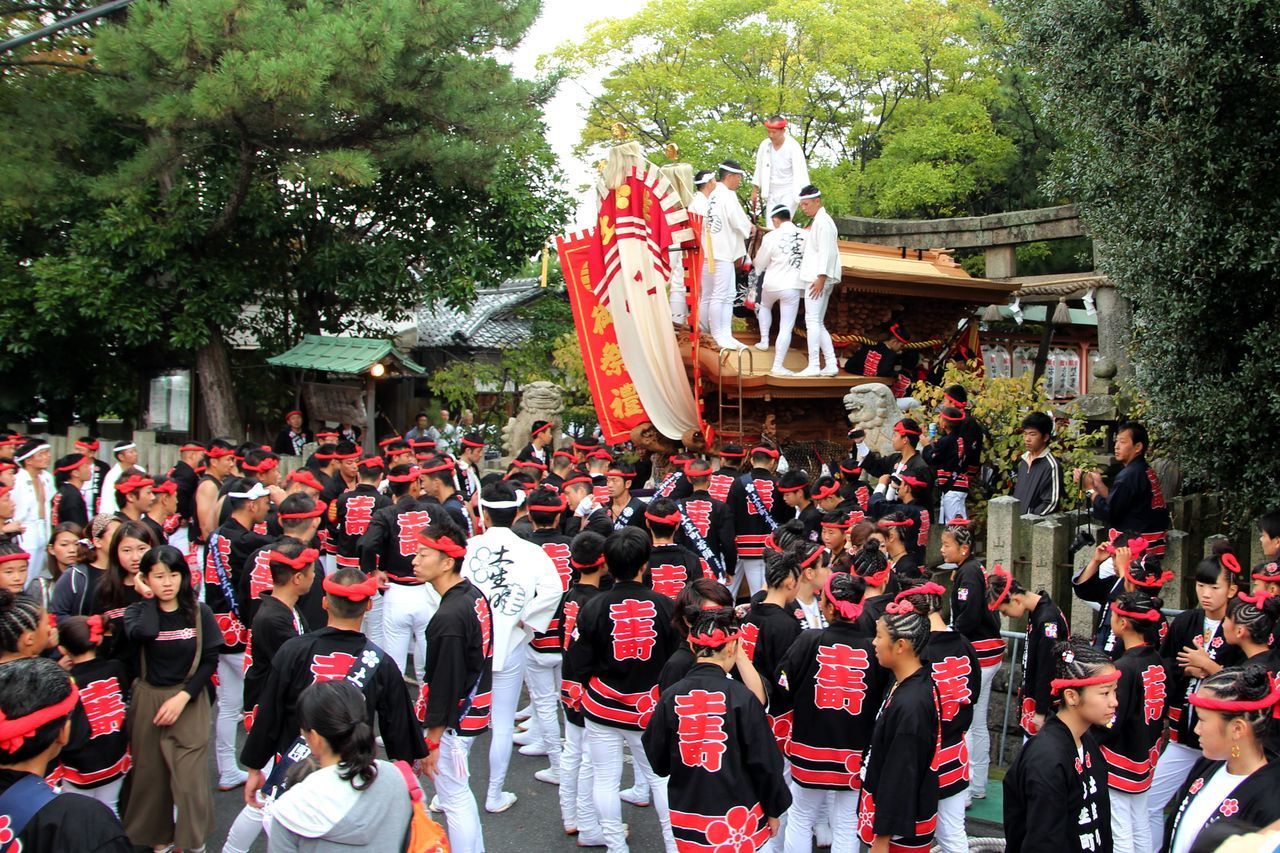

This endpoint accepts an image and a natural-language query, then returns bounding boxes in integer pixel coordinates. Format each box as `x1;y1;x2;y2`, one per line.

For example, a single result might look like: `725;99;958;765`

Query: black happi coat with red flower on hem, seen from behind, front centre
643;662;791;849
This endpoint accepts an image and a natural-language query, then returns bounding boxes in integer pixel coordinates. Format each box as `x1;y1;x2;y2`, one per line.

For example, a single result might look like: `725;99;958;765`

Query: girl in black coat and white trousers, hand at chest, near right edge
1147;543;1244;840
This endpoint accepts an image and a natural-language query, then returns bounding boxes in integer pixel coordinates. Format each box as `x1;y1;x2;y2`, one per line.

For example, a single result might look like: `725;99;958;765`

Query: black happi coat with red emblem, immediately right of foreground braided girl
920;631;982;799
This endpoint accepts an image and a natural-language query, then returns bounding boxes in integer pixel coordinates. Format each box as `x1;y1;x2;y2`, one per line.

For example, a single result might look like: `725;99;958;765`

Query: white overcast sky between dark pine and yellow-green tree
501;0;645;231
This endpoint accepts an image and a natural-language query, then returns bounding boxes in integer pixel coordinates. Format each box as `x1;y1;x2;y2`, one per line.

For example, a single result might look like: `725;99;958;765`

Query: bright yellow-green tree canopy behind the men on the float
550;0;1055;216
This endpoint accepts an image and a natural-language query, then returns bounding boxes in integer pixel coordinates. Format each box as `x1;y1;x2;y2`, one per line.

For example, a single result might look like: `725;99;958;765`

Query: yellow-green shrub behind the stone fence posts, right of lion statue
911;362;1102;523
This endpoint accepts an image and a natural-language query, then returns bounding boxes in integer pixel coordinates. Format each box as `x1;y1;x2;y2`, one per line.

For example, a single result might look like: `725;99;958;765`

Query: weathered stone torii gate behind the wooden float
836;205;1132;375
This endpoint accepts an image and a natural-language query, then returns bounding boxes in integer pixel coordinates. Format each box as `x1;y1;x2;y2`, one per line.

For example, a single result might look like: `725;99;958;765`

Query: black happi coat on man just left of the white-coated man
417;580;493;738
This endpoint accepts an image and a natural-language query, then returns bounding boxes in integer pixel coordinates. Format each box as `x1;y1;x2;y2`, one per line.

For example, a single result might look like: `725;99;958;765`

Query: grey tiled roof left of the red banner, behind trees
417;278;544;350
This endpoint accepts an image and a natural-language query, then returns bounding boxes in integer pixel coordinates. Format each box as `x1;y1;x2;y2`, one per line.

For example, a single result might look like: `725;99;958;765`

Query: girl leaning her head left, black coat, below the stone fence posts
987;565;1070;738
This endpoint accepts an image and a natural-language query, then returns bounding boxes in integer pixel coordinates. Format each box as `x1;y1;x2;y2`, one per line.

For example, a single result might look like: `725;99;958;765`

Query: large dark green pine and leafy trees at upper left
0;0;567;425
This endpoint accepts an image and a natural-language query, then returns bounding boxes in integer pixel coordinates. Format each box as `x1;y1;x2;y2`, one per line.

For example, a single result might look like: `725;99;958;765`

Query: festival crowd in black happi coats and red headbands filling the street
0;386;1280;853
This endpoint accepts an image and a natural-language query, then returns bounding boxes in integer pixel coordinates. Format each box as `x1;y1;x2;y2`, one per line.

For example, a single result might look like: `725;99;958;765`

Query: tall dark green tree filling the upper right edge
1004;0;1280;525
